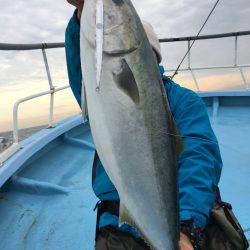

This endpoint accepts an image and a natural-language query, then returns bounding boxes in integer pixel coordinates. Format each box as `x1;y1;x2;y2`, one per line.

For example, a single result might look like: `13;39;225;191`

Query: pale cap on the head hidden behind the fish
142;21;162;63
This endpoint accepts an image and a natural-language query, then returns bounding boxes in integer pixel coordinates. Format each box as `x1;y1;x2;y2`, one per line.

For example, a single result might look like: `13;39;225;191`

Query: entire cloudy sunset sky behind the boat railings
0;0;250;131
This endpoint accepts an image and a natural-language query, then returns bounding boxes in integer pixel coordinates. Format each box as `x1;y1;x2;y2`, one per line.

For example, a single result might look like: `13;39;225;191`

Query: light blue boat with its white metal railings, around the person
0;31;250;250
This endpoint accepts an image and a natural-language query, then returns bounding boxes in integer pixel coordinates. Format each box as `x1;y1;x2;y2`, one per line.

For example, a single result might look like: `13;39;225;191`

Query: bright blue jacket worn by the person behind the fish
66;11;222;228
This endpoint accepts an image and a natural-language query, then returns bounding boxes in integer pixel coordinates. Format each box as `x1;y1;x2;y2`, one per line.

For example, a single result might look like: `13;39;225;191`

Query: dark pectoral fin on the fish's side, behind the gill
113;59;140;104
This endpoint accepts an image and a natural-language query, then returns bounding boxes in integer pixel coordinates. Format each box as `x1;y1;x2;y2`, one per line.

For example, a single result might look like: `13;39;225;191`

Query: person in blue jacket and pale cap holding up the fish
65;0;222;250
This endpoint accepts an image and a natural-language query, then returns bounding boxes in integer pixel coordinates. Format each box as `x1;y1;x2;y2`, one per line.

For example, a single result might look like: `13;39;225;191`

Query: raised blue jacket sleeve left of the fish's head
65;11;82;107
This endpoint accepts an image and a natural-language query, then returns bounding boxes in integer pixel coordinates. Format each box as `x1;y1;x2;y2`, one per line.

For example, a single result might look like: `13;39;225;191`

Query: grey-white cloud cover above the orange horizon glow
0;0;250;131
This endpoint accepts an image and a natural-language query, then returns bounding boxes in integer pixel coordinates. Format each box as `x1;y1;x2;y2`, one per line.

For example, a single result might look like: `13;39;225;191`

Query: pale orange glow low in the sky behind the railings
0;66;249;131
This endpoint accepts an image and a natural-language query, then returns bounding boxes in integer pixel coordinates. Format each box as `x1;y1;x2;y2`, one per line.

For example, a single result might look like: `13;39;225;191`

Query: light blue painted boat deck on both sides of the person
0;101;250;250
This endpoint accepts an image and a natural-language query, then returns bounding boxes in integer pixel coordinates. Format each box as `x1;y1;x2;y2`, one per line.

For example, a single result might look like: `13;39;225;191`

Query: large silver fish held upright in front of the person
80;0;178;250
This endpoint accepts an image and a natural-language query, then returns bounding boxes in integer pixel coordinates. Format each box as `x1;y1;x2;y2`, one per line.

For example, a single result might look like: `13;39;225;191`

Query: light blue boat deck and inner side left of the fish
0;123;97;250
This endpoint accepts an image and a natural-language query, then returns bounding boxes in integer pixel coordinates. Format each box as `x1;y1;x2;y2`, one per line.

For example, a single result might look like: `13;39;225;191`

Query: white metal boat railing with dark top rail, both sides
0;31;250;166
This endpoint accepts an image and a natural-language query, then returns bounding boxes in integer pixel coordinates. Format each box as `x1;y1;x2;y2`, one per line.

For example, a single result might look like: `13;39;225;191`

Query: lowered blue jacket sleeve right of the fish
166;80;222;228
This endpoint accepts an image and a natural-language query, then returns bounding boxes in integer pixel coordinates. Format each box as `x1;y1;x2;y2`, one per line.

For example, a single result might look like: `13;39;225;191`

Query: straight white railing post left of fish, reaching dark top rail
42;48;55;128
